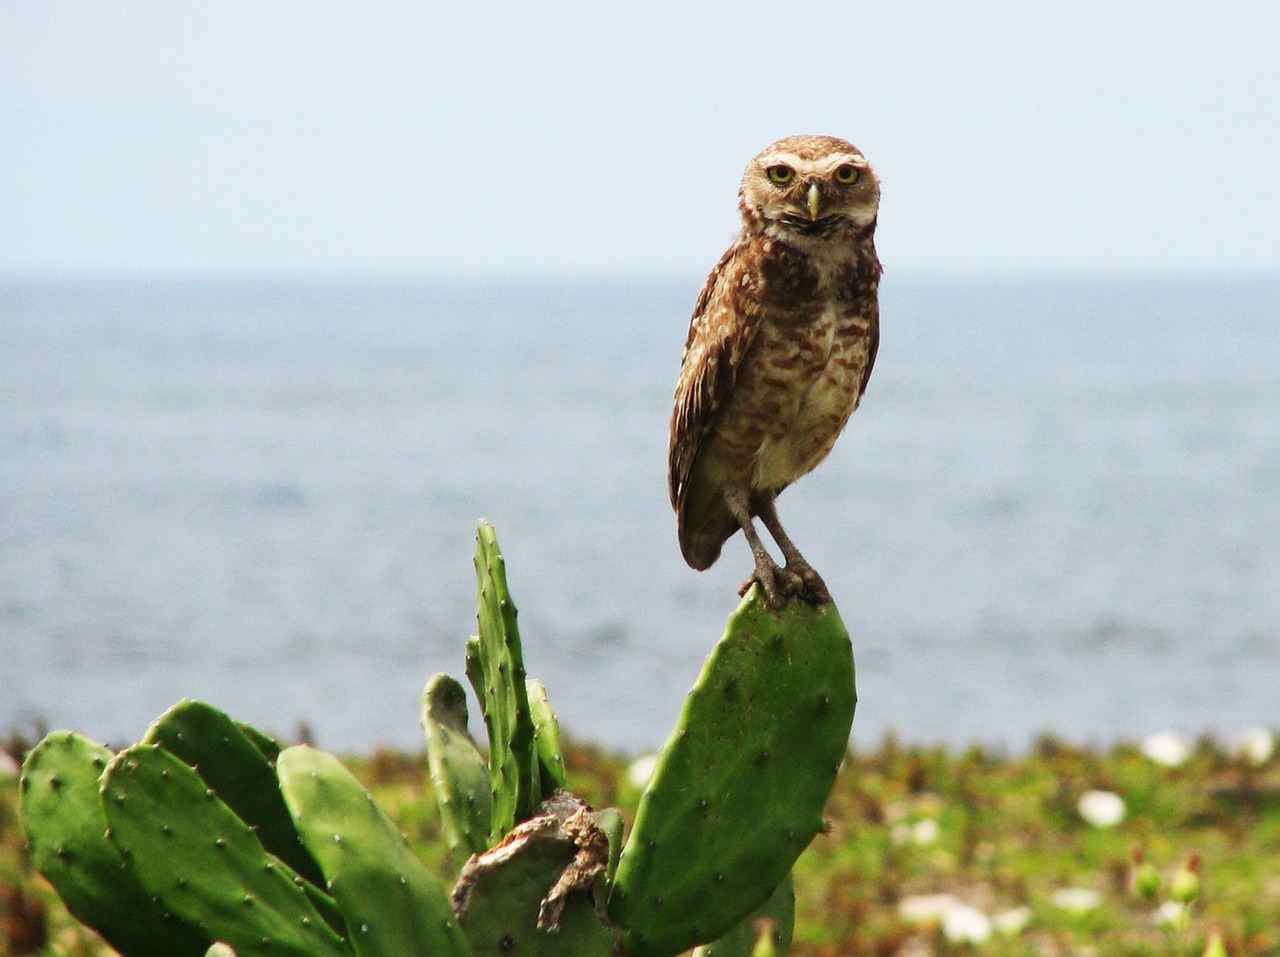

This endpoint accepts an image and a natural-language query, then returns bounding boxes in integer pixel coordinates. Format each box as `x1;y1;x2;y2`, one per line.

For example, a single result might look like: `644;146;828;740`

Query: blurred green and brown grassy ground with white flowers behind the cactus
0;738;1280;957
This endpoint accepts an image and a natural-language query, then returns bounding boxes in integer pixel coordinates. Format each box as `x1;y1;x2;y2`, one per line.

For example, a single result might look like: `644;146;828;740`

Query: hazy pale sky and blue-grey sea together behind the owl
0;0;1280;750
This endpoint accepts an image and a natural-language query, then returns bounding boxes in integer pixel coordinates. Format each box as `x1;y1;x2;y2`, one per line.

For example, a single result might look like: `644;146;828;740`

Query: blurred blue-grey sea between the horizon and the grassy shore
0;274;1280;750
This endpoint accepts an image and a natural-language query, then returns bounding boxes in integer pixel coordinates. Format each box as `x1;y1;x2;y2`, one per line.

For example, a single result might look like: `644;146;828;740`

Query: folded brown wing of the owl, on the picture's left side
667;241;760;513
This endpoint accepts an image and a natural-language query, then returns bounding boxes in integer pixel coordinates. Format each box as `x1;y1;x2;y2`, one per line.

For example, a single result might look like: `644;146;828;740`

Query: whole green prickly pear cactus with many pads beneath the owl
22;523;855;957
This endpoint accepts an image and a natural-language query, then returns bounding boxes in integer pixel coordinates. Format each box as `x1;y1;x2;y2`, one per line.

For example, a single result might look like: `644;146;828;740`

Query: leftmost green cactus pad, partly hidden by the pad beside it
20;731;209;957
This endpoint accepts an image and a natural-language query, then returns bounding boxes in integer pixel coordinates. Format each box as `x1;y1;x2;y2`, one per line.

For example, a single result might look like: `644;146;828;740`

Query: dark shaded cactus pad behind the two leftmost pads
141;699;324;884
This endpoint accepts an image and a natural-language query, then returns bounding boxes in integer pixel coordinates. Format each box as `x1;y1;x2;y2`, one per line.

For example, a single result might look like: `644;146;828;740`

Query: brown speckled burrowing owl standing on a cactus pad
669;136;881;608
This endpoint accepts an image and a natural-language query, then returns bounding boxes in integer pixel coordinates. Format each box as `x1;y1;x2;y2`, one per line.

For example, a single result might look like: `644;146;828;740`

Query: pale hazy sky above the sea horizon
0;0;1280;275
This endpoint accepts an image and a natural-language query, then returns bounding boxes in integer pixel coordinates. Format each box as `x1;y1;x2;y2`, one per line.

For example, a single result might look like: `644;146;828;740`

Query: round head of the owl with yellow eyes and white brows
739;136;879;239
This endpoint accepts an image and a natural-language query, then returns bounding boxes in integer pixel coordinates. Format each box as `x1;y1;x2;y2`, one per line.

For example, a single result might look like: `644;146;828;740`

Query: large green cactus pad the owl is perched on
609;587;855;957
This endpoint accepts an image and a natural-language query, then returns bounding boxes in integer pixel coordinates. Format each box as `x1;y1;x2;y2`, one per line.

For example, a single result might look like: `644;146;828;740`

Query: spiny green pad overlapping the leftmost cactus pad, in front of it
102;745;352;957
